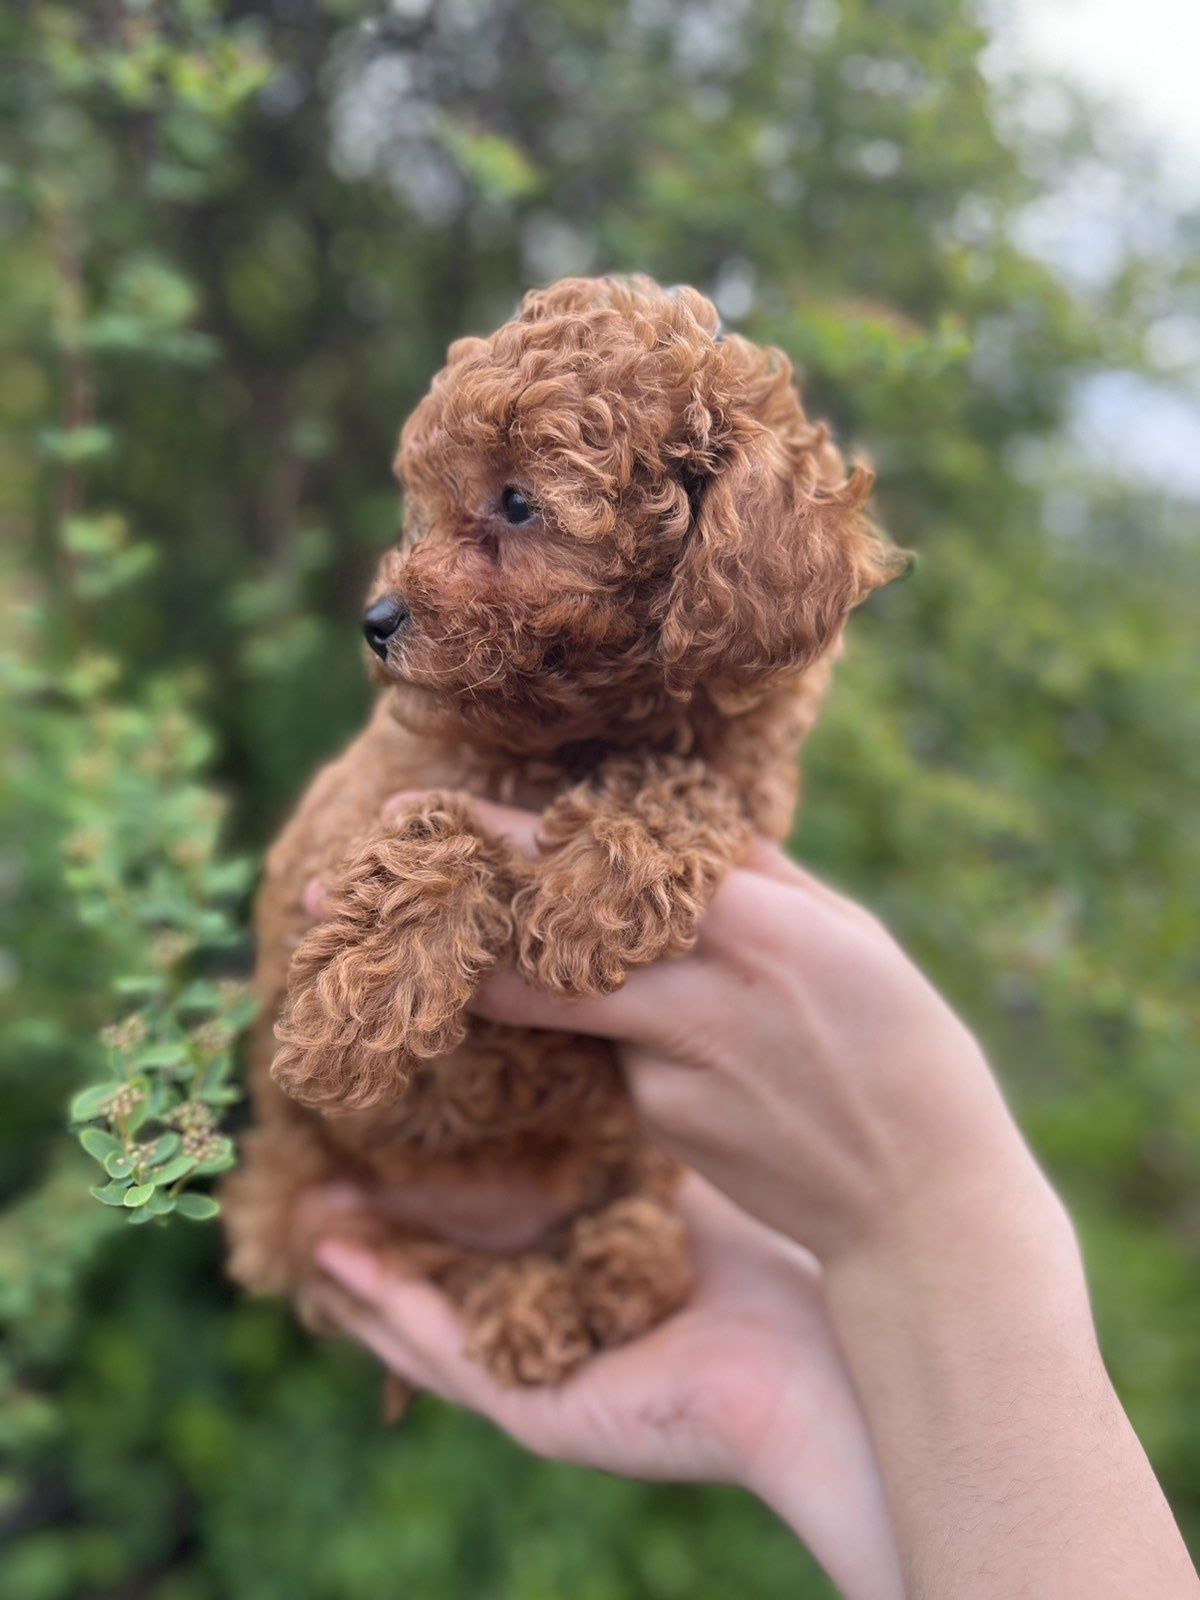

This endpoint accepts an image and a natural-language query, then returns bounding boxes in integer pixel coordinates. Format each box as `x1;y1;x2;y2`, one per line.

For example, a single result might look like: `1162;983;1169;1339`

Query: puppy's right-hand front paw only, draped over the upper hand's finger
514;818;707;997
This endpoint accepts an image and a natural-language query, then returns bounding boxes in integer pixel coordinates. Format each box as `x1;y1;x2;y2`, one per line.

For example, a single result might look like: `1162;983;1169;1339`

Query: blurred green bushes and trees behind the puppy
0;0;1200;1600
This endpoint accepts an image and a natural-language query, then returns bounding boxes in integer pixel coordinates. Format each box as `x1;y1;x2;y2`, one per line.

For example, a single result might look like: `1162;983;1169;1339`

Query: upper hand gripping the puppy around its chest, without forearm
377;797;1058;1261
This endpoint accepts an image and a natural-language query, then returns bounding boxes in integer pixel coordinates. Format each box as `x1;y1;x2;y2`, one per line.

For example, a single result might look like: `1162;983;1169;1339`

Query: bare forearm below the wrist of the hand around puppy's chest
827;1163;1200;1600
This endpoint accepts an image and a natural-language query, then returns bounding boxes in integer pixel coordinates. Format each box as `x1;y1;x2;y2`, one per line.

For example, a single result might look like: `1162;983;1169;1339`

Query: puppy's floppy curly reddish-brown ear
659;424;904;699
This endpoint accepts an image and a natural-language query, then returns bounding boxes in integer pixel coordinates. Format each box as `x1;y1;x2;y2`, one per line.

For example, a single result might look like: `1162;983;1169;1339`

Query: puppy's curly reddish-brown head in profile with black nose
363;277;894;749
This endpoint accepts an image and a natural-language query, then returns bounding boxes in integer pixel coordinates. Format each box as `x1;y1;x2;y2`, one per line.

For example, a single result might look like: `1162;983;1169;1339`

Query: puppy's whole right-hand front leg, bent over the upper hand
514;757;749;995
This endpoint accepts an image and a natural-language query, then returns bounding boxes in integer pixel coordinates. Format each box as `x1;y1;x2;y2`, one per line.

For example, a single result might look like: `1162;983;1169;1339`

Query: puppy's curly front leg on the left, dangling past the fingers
270;795;518;1112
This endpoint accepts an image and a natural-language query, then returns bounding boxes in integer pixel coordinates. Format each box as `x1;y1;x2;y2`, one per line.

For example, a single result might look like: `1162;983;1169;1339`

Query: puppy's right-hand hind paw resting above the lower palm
566;1195;693;1346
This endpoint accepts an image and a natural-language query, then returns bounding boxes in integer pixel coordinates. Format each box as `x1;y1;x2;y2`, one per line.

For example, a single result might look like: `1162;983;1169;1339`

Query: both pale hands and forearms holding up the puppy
310;802;1200;1600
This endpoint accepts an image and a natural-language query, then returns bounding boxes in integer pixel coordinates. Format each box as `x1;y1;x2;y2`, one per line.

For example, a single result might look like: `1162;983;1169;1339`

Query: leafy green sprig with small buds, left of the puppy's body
55;643;253;1222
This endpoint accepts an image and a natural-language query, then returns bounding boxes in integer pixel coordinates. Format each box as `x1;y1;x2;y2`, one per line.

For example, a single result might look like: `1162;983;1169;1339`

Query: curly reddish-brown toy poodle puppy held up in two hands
226;277;894;1384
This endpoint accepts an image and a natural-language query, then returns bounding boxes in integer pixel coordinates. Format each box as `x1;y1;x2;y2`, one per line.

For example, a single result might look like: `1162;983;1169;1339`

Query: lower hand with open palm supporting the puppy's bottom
306;1176;902;1600
